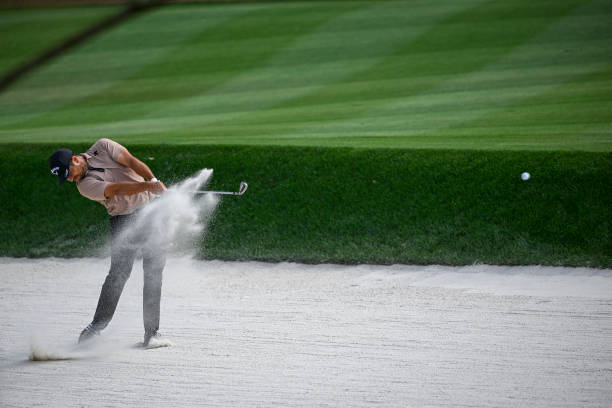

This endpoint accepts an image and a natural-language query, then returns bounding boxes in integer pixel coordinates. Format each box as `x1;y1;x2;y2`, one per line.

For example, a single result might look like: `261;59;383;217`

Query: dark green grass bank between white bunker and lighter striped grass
0;144;612;268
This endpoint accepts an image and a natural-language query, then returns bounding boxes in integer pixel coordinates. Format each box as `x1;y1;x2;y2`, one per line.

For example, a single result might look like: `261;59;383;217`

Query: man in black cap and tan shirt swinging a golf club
49;139;166;347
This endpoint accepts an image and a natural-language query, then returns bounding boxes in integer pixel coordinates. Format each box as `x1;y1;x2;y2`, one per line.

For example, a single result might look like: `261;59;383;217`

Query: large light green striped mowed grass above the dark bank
0;0;612;152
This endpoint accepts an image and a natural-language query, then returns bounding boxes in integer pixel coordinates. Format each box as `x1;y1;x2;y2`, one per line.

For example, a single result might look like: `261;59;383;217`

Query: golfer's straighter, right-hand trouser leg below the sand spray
142;249;166;333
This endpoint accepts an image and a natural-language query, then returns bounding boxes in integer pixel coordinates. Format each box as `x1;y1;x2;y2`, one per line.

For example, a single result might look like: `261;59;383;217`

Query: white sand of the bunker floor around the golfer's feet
0;258;612;407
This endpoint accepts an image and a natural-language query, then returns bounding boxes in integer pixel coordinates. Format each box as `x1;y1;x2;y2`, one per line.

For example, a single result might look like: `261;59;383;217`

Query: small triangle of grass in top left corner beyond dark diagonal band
0;6;118;75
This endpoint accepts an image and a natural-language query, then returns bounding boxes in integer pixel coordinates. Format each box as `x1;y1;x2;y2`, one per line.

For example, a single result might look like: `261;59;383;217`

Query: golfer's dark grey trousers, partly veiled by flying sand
92;214;166;333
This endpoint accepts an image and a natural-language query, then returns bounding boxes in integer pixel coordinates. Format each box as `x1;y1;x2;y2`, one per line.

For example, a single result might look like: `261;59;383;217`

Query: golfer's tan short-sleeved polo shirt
76;139;154;215
